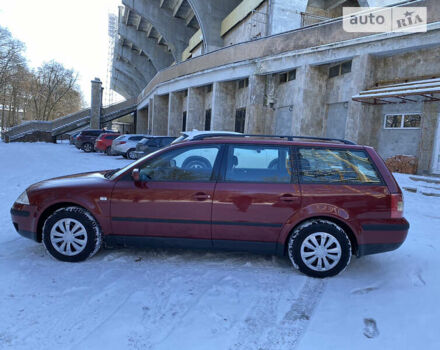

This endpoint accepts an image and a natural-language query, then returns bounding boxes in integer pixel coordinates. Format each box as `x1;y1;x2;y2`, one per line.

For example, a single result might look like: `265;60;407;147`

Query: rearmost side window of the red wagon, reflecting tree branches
299;148;382;185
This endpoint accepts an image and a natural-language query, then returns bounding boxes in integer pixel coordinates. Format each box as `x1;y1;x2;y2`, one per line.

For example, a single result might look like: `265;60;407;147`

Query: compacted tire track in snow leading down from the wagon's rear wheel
259;278;327;350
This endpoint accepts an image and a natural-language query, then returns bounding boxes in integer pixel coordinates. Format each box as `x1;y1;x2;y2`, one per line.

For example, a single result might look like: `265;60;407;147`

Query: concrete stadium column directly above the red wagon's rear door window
245;75;274;134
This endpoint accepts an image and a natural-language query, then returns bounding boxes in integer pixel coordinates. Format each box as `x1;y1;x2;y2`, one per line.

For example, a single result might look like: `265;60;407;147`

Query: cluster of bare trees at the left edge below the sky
0;27;84;131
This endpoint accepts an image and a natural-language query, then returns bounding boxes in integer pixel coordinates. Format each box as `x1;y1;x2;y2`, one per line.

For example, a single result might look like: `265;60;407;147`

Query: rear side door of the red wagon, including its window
212;144;301;252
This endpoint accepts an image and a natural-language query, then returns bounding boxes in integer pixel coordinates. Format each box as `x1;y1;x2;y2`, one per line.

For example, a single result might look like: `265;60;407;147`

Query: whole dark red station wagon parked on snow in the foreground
11;135;409;277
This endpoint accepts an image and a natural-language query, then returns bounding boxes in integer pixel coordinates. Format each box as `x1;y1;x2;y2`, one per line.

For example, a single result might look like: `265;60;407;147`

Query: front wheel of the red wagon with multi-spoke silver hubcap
43;207;102;262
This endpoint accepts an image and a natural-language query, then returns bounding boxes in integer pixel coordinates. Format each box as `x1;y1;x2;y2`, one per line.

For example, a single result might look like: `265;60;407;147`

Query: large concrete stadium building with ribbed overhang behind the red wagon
111;0;440;173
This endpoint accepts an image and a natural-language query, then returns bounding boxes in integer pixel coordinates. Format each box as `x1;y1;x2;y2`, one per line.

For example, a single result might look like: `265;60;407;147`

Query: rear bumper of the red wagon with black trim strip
356;218;409;257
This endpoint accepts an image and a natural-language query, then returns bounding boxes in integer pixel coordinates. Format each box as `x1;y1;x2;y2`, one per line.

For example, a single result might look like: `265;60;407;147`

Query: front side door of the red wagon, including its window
111;145;221;246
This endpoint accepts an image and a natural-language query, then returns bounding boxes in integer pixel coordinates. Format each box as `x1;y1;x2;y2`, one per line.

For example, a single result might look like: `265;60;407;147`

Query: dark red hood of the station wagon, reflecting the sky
28;170;111;192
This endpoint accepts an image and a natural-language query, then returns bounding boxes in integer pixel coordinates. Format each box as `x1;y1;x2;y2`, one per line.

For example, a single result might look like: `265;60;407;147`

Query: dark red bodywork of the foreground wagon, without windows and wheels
11;138;409;255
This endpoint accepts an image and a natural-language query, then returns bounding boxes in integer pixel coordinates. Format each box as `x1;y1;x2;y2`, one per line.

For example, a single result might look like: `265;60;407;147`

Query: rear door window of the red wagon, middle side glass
225;145;291;183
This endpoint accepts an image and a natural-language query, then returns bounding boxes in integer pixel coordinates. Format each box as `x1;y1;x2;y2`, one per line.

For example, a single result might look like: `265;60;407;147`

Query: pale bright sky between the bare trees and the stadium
0;0;121;105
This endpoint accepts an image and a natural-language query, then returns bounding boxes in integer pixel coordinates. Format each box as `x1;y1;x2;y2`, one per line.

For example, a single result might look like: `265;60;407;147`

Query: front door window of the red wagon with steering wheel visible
140;146;219;182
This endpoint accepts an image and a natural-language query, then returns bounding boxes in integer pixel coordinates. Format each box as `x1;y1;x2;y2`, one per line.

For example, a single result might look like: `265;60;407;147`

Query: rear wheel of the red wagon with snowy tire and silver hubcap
287;220;351;278
